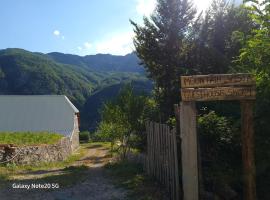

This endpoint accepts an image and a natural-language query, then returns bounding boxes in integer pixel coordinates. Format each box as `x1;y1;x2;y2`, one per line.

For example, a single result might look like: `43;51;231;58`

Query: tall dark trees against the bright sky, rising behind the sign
131;0;255;122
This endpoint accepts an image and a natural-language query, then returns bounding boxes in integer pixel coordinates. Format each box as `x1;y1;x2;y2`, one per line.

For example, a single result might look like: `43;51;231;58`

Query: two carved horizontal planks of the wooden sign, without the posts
181;74;256;101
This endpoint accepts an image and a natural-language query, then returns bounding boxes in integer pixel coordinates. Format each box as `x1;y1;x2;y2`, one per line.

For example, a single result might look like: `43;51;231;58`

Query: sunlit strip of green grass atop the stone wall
0;132;63;146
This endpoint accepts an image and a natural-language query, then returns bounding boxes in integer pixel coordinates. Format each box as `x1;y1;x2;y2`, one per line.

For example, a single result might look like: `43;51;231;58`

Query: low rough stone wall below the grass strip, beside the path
0;137;72;164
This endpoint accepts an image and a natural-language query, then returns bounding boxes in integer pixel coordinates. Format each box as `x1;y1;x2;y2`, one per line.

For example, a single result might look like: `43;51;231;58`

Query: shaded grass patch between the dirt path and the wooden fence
106;161;168;200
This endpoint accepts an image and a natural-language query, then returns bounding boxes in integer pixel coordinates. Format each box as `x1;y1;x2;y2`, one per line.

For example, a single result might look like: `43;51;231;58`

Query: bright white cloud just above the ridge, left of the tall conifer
94;31;134;55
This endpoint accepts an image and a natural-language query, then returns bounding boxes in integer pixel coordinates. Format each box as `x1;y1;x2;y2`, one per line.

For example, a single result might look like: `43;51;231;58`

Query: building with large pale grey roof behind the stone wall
0;95;79;150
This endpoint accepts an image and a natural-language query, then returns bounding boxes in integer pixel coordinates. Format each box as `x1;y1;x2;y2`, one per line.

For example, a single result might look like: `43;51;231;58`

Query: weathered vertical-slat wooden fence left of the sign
144;122;180;200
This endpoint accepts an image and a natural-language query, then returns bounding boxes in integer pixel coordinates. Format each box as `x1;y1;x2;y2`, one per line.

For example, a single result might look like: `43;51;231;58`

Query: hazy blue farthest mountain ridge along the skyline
47;52;144;73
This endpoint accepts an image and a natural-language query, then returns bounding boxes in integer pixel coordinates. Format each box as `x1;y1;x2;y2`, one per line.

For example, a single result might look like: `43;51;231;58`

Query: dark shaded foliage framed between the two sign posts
198;111;242;196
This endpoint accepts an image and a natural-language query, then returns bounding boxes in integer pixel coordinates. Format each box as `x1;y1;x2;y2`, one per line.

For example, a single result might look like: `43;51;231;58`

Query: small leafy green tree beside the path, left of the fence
97;85;152;157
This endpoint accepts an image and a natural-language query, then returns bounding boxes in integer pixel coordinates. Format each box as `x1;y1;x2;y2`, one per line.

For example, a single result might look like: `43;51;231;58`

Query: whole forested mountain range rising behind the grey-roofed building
0;49;152;129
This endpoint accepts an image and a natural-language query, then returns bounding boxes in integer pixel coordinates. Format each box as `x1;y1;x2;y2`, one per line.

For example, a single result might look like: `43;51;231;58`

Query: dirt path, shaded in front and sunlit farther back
0;145;127;200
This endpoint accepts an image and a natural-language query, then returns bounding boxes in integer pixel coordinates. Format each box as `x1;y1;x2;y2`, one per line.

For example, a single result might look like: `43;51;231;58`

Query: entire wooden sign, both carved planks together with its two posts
180;74;256;200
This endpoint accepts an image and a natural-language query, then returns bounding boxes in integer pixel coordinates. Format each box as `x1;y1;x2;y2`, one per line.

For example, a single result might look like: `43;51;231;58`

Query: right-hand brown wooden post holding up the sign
241;100;256;200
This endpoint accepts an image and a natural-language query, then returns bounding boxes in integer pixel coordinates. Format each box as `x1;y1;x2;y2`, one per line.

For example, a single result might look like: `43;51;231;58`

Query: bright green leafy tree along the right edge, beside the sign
236;0;270;199
